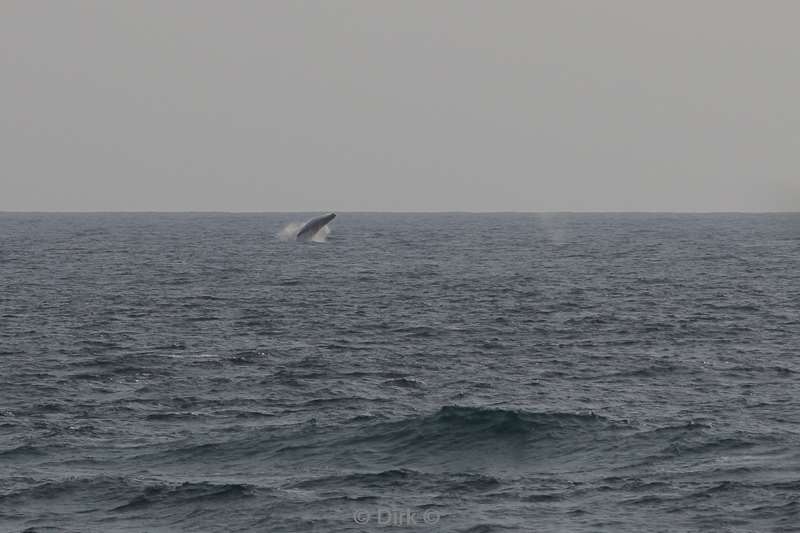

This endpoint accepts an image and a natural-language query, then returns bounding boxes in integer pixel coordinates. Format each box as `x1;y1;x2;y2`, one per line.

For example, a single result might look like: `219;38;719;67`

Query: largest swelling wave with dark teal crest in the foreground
131;406;622;467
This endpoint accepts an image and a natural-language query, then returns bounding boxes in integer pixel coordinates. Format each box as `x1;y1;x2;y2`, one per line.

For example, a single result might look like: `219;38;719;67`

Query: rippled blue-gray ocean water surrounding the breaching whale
0;213;800;532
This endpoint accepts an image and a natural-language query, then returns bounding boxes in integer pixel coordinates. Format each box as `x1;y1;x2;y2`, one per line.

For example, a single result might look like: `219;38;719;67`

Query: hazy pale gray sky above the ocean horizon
0;0;800;211
